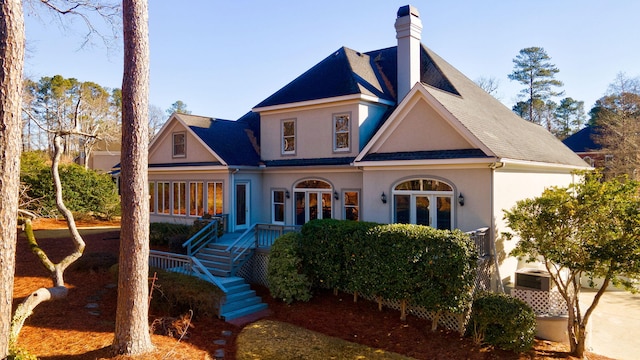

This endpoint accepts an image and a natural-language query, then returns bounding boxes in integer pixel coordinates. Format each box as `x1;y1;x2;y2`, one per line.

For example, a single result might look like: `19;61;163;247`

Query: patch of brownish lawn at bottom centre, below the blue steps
236;320;411;360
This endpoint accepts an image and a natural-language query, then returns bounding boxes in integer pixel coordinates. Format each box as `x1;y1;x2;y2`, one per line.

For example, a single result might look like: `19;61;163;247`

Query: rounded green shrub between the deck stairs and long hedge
267;232;311;304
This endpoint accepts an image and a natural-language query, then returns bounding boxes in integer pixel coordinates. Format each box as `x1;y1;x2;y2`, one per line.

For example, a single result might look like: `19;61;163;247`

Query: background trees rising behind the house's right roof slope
476;47;640;179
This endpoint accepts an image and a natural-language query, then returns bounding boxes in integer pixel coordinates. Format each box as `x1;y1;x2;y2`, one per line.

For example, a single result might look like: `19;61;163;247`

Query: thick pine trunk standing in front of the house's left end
112;0;153;355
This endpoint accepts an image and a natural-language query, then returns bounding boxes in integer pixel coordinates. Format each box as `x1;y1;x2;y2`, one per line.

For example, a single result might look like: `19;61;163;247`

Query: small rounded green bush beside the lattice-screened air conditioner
468;293;536;352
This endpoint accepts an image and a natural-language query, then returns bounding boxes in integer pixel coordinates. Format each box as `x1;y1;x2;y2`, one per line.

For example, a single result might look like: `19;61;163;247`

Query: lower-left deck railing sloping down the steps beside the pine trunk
149;250;227;293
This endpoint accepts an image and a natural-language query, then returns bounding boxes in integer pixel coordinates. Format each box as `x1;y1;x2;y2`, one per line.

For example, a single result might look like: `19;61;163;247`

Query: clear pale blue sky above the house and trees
25;0;640;119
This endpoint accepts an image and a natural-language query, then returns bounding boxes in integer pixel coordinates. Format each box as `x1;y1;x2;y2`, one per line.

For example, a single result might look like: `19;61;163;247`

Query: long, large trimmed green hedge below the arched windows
269;219;477;317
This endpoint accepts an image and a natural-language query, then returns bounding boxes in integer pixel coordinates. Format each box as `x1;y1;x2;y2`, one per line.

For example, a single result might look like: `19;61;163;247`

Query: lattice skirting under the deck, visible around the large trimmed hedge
237;249;500;333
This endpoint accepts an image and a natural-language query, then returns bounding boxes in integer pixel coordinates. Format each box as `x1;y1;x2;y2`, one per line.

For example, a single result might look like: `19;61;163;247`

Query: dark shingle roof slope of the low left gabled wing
176;113;260;166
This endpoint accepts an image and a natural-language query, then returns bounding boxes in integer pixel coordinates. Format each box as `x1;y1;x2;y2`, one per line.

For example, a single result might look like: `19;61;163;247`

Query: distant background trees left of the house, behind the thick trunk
22;75;190;168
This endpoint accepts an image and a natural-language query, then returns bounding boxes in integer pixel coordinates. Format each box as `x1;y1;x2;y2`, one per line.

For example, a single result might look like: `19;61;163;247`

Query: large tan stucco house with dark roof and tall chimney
149;6;588;292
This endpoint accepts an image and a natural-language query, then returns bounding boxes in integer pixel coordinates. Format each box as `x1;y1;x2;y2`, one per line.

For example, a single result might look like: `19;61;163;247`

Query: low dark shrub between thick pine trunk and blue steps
149;268;224;316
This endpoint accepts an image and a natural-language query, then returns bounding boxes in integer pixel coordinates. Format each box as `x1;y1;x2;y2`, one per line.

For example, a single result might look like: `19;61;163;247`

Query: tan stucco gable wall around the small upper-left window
149;119;217;164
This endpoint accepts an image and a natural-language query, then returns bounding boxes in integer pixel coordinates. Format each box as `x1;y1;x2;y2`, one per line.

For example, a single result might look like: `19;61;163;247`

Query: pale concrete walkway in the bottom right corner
580;289;640;360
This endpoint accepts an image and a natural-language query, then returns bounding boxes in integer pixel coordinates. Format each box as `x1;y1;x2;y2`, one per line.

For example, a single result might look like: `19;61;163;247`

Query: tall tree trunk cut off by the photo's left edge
0;0;24;359
